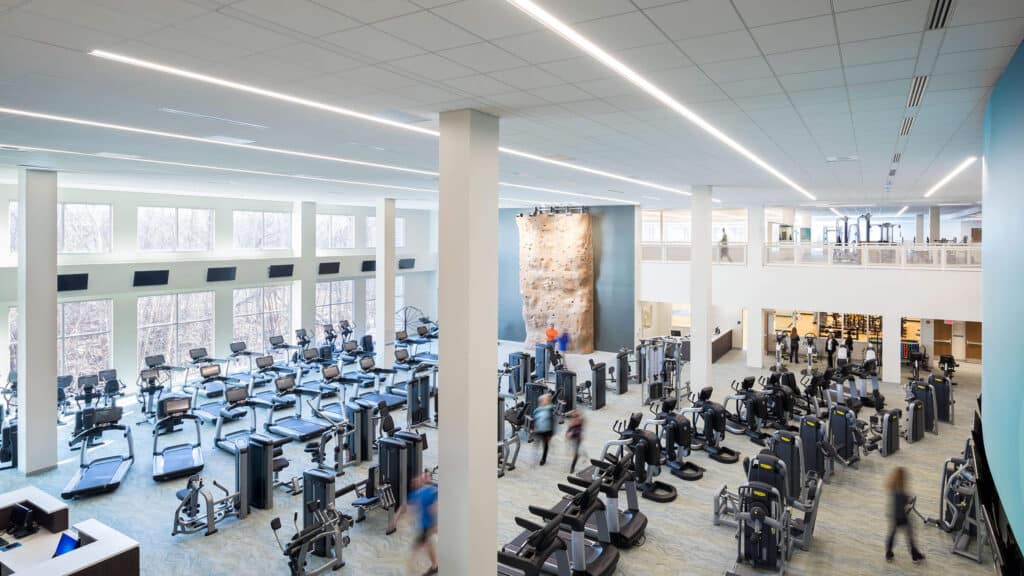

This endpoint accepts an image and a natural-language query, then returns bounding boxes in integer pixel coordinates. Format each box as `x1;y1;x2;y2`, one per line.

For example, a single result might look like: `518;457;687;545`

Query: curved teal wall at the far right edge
981;41;1024;534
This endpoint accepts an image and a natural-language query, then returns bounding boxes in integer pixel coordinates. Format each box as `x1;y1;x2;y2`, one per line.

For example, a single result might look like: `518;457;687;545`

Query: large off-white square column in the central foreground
437;110;498;576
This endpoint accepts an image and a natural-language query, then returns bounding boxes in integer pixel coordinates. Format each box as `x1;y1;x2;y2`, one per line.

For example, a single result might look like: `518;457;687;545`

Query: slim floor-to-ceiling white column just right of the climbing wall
690;186;712;389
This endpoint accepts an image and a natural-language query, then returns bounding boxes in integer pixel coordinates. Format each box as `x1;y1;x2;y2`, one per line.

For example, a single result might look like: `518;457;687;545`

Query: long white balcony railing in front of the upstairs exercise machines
764;243;981;270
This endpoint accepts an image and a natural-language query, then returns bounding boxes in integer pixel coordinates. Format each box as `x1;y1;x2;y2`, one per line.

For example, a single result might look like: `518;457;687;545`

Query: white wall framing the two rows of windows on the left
0;184;437;380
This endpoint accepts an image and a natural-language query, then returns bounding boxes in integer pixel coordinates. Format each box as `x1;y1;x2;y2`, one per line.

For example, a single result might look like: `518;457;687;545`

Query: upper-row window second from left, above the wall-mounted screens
137;206;213;252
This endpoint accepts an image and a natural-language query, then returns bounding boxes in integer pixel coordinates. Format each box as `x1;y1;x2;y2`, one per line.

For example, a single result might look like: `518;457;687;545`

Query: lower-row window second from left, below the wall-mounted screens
137;292;213;369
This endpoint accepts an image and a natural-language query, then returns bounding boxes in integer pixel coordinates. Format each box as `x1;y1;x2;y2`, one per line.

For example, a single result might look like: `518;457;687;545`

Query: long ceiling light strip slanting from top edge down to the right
507;0;817;200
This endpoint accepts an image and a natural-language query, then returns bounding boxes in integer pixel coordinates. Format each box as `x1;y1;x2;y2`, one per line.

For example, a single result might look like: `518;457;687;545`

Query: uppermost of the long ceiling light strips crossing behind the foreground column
89;50;690;196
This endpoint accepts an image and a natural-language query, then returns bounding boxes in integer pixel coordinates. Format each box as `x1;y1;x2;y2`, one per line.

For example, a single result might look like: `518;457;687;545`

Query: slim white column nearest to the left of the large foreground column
374;198;395;368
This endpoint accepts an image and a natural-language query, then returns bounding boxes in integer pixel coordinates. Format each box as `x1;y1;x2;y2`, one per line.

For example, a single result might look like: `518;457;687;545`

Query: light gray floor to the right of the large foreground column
498;343;991;575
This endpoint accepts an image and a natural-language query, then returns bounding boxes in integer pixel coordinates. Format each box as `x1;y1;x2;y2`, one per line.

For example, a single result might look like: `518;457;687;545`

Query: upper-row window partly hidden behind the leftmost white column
7;202;113;254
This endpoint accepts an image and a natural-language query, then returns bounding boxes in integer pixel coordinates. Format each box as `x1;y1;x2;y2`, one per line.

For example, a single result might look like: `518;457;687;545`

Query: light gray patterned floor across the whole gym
0;343;989;575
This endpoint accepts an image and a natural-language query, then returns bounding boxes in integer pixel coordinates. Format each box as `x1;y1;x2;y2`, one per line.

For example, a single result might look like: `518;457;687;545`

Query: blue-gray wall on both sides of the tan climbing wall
498;206;636;352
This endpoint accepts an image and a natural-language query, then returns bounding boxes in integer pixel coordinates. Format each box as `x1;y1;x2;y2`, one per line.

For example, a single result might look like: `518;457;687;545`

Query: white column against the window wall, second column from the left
292;202;316;338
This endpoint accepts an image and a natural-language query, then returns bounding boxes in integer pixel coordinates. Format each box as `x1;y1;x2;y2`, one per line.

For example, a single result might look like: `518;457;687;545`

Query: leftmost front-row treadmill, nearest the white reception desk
60;406;135;500
